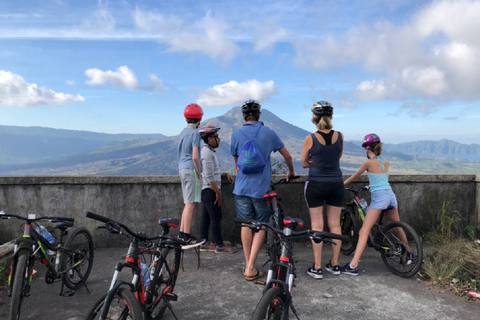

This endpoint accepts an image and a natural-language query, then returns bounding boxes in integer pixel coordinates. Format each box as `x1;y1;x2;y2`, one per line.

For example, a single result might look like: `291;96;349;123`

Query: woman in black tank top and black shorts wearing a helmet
302;101;344;279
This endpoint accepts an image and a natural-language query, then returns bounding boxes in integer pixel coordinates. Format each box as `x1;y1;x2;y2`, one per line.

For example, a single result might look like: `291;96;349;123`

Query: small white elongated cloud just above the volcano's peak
197;80;275;107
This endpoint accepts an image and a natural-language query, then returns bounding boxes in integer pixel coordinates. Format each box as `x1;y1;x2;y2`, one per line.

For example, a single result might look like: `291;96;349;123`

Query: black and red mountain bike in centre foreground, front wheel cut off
236;217;347;320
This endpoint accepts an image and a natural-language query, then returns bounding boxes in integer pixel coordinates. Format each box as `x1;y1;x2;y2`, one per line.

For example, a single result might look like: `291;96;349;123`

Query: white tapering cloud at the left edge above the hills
0;70;85;107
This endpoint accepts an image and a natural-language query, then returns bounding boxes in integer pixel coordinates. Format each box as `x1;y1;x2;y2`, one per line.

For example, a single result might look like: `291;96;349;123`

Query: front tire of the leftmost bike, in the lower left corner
9;249;30;320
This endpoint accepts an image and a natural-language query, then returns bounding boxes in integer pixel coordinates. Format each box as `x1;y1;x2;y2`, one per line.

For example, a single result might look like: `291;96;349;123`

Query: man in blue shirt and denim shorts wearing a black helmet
230;100;295;281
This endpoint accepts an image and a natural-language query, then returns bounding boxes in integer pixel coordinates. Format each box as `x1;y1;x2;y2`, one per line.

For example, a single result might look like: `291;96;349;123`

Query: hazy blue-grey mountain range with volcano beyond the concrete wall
0;107;480;175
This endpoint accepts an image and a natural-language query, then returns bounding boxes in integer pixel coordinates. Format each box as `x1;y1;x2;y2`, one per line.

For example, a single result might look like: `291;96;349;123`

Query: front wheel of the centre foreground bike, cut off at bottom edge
252;287;289;320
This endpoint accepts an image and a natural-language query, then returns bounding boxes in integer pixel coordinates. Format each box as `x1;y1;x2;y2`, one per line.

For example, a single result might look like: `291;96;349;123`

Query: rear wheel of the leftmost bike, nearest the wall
60;228;93;290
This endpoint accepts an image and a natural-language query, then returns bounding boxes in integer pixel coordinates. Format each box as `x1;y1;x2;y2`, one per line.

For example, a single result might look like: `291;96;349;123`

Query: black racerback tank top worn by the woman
308;130;343;182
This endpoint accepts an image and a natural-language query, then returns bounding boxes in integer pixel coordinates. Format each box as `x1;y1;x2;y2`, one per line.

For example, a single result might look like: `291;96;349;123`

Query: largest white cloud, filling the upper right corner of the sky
294;0;480;104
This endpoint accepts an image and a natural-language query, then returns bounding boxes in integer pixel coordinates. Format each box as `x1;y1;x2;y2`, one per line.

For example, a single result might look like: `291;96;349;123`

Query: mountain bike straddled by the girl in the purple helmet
340;186;423;278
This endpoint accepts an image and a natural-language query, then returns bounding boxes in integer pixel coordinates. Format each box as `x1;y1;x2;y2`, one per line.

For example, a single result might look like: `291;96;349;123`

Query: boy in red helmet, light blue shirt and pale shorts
177;103;203;244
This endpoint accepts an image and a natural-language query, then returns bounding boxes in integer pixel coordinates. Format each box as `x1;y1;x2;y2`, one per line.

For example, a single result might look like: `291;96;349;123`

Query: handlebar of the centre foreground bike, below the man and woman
235;218;348;243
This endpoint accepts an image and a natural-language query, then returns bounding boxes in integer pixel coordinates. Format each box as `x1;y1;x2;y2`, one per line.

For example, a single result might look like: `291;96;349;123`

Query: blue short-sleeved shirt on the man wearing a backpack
230;121;285;198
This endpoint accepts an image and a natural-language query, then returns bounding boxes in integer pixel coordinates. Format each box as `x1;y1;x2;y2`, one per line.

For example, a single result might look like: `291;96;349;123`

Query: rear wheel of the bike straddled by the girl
378;221;423;278
